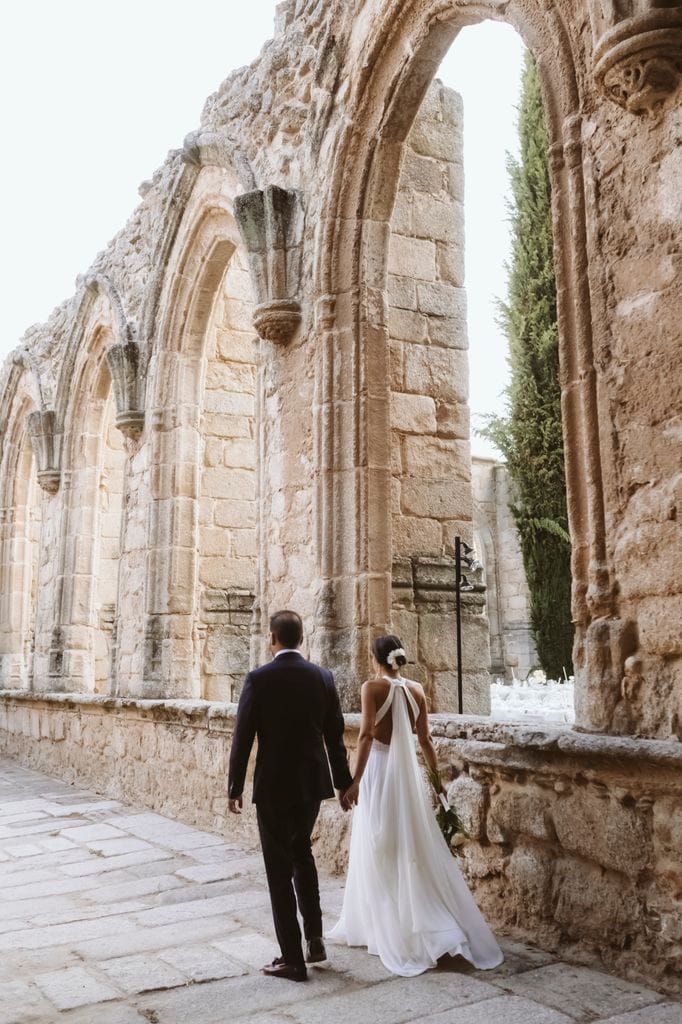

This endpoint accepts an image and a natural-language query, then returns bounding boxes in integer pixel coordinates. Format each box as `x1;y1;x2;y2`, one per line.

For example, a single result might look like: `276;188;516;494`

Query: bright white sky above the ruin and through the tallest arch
0;0;522;454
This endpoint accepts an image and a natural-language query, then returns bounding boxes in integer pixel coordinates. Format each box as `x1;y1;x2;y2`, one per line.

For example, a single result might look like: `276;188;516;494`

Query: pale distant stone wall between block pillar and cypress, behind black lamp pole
471;457;539;681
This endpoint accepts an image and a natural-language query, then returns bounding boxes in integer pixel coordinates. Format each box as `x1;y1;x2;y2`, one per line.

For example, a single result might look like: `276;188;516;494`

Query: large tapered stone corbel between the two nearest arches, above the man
235;185;303;344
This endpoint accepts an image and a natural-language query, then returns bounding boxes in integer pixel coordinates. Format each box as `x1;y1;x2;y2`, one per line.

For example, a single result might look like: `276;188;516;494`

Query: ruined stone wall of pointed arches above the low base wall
0;0;682;720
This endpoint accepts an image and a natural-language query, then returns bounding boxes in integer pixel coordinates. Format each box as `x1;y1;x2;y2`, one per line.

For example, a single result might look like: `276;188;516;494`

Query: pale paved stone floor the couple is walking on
0;761;682;1024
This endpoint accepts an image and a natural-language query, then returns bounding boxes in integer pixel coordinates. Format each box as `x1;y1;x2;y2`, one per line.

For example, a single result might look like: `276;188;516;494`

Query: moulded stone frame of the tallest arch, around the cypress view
317;0;627;725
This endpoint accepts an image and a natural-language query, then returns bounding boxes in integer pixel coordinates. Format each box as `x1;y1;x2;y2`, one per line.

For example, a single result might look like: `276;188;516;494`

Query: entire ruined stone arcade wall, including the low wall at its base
0;0;682;984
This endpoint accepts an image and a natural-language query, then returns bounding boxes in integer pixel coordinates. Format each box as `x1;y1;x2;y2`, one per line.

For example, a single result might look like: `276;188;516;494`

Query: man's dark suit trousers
256;801;323;966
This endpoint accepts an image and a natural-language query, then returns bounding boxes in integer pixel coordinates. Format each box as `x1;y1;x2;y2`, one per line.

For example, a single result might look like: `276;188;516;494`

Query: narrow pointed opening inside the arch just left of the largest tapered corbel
196;249;257;701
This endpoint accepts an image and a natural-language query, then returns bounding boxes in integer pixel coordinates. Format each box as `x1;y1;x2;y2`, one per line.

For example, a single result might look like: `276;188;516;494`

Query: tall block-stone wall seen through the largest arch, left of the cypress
387;82;491;714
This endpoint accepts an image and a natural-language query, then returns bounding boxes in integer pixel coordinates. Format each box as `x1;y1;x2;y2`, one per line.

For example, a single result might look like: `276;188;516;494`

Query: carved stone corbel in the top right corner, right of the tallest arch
590;0;682;115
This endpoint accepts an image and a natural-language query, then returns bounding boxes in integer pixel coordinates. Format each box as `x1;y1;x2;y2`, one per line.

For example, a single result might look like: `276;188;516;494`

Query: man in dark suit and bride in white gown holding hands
228;611;503;981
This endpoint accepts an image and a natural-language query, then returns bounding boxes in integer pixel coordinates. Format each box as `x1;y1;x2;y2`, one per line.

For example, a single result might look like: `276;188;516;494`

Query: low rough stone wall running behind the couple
0;691;682;992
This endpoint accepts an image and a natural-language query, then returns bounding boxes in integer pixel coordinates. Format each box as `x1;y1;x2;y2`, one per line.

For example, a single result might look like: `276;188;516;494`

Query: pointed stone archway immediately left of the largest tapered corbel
141;184;258;700
